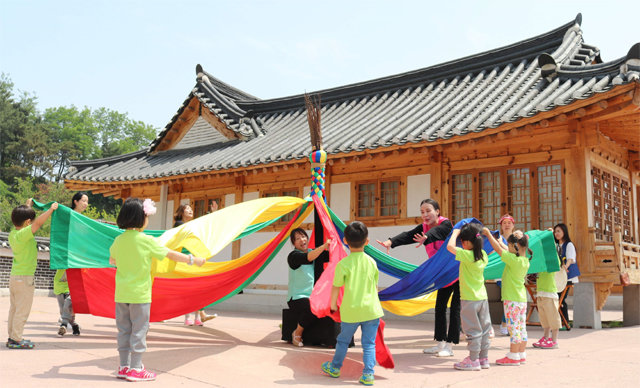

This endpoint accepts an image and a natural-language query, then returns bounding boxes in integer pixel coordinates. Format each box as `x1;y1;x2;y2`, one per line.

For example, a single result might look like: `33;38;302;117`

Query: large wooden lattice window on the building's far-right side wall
591;167;633;242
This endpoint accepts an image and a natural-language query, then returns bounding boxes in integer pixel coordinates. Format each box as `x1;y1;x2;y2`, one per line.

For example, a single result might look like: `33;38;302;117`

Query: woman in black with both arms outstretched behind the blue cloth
378;198;460;357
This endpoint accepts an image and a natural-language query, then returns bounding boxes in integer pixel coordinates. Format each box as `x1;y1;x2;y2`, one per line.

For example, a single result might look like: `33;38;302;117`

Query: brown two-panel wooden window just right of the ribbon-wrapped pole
356;180;400;218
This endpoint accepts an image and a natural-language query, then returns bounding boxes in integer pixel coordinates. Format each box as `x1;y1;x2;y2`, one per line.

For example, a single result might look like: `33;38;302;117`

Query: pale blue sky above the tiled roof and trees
0;0;640;128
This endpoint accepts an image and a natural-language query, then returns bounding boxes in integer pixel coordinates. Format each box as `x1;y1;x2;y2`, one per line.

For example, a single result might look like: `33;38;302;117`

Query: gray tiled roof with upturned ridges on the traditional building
66;15;639;182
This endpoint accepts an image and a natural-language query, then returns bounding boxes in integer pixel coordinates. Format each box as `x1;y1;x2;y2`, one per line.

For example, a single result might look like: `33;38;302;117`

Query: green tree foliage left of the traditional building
0;74;157;235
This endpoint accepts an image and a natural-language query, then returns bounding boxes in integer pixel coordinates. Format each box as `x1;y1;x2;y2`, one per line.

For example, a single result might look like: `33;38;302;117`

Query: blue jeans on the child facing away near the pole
331;318;380;374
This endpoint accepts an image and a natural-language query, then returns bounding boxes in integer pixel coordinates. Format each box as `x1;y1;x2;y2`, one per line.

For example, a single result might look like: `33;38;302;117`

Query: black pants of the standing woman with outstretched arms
434;282;460;344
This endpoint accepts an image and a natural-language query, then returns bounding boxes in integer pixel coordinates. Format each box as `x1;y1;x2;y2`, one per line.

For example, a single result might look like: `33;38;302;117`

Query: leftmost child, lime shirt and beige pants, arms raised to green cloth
7;199;58;349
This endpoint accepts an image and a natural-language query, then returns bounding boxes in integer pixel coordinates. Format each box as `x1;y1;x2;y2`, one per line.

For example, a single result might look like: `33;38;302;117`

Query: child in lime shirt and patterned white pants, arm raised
482;228;531;366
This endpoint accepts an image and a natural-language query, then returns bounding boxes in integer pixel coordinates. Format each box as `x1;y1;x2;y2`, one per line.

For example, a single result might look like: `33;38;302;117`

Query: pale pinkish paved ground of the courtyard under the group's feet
0;296;640;388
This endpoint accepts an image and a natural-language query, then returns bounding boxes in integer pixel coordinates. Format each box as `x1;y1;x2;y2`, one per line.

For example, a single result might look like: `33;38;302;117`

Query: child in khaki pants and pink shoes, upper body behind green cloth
533;253;562;349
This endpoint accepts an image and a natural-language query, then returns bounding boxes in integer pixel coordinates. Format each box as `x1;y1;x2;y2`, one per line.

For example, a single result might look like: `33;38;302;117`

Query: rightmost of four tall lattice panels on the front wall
538;164;564;229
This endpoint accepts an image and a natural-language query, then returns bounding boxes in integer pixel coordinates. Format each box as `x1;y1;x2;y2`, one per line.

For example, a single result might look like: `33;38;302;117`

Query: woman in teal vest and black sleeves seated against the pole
287;228;331;346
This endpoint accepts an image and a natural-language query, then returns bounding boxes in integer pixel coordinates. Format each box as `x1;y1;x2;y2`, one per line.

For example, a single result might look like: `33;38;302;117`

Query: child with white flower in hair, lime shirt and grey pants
109;198;205;381
